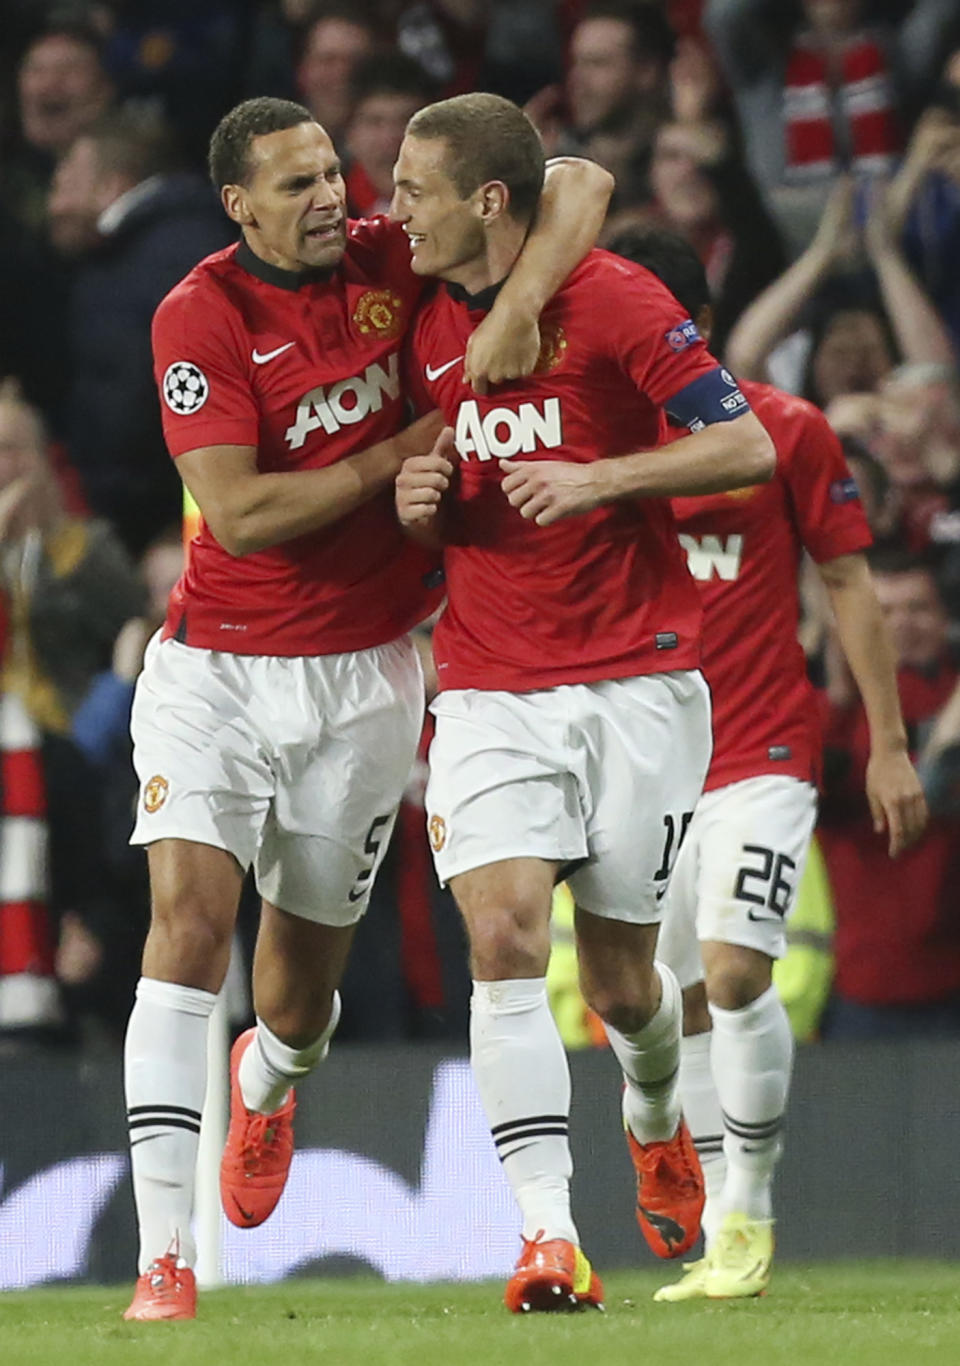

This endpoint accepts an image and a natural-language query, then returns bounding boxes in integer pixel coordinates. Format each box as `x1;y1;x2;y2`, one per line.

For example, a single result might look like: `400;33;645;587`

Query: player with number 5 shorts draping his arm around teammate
126;98;610;1318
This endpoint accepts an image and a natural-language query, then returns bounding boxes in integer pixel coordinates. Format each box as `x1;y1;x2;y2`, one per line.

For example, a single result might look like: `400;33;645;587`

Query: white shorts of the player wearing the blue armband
426;671;711;923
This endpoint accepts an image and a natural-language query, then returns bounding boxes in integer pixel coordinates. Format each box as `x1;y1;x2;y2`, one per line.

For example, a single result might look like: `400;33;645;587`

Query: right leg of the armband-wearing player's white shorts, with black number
568;671;713;923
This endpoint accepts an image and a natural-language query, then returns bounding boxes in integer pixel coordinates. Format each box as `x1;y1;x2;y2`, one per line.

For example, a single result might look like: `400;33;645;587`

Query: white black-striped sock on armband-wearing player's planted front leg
470;977;579;1244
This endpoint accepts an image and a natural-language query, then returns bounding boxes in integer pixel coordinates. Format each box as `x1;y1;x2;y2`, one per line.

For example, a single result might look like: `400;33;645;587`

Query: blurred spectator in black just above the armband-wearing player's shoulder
606;122;785;357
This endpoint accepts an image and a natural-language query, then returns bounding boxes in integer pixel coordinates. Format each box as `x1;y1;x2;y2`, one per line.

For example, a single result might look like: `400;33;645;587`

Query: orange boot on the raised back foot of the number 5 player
220;1029;296;1228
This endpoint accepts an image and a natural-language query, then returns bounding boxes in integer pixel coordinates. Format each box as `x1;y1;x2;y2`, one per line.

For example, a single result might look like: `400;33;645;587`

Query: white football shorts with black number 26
657;773;817;986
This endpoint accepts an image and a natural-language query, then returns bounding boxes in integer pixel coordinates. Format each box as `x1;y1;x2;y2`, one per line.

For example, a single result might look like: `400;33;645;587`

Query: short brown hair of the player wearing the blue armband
407;93;546;223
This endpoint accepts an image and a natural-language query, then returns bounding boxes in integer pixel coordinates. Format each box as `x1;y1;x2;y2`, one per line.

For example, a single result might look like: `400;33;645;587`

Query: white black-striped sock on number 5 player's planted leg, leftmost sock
123;977;217;1273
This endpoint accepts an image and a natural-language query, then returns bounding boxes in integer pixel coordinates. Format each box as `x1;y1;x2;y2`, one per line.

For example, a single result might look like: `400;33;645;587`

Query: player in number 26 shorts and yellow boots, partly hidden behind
603;231;924;1300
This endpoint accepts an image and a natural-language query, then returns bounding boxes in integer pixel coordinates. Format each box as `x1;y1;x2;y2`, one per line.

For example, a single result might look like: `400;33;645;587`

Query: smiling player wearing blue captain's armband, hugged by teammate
392;94;773;1310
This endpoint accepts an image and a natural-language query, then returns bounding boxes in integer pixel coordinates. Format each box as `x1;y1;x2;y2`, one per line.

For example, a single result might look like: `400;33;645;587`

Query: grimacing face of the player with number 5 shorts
223;123;347;272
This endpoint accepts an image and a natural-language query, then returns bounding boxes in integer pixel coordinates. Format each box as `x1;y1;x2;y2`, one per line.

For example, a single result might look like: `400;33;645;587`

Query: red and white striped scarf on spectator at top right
784;33;900;180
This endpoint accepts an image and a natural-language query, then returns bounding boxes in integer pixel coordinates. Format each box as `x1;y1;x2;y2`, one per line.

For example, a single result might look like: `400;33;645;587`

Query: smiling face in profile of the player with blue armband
391;134;486;288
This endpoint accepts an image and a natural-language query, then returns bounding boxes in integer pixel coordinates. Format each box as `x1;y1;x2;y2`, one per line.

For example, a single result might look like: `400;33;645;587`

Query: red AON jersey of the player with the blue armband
414;251;726;691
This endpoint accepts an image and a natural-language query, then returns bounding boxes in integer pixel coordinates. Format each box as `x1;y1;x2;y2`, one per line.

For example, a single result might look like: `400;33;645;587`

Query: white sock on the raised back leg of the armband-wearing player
604;963;683;1143
